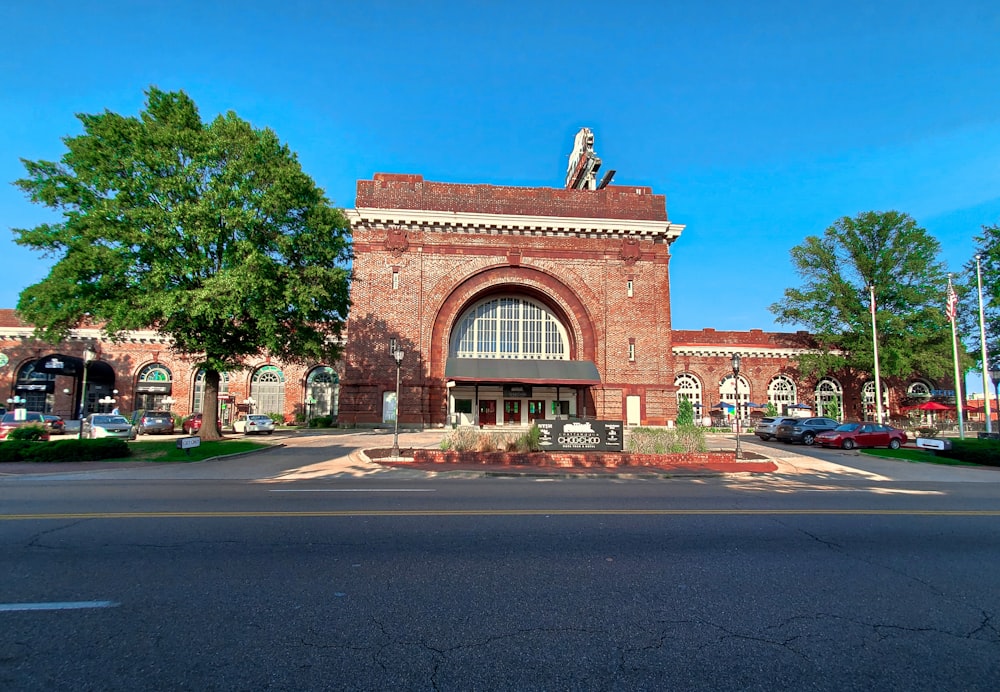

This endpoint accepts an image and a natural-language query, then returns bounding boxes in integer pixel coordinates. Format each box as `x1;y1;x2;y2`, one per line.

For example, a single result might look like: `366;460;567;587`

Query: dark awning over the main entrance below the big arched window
444;358;601;386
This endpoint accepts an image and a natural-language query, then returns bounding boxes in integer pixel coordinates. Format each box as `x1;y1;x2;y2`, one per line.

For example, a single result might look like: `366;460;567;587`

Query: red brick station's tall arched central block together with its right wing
340;174;934;426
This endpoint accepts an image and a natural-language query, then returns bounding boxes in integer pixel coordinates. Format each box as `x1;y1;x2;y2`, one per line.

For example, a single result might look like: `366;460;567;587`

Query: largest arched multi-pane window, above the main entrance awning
451;297;569;360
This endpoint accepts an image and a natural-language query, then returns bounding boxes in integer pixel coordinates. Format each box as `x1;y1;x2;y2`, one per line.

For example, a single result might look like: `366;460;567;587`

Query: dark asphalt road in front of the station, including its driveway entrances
0;435;1000;690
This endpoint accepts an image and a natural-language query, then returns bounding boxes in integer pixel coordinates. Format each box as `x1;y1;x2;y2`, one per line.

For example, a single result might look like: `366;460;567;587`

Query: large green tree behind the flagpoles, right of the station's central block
771;211;953;378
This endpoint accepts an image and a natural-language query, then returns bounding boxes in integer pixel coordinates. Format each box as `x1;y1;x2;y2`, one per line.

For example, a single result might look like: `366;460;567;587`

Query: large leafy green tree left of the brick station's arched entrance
14;87;351;438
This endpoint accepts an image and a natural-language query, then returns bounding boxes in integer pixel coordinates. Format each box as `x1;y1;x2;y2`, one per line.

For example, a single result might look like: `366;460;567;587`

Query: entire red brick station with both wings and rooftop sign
0;131;936;426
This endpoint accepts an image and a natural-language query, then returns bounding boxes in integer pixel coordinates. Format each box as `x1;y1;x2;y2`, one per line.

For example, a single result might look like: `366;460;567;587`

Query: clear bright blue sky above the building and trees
0;0;1000;389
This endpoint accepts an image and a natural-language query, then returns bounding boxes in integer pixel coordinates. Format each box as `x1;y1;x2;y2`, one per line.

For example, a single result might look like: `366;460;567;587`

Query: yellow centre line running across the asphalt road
0;509;1000;521
